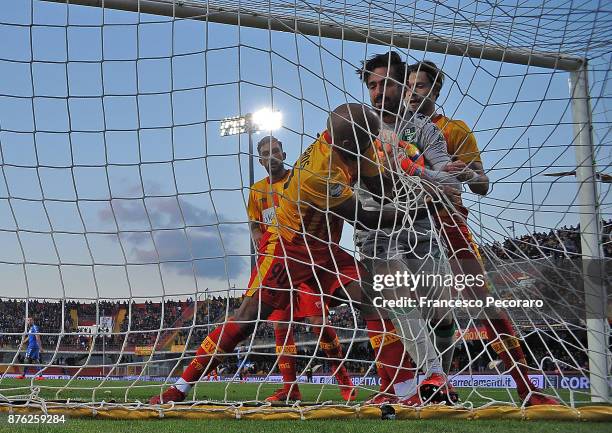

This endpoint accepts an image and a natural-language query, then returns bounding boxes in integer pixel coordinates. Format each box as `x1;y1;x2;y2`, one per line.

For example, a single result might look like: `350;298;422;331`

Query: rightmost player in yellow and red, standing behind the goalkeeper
405;61;558;405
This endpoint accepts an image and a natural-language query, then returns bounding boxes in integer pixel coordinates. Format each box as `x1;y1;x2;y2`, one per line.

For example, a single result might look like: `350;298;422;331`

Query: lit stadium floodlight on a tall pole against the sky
219;108;283;268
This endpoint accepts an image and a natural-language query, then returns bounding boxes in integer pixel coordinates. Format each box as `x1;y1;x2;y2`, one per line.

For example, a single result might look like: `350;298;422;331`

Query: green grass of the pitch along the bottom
0;379;612;433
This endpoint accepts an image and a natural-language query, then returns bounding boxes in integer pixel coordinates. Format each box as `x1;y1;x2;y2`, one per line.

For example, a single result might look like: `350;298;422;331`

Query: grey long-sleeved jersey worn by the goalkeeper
355;111;461;246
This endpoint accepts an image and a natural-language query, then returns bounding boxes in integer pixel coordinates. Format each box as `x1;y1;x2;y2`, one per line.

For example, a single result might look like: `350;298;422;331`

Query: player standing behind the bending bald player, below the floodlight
248;136;357;401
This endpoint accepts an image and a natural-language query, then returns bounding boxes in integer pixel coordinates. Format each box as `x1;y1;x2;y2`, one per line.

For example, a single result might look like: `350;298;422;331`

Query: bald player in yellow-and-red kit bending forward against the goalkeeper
150;104;414;404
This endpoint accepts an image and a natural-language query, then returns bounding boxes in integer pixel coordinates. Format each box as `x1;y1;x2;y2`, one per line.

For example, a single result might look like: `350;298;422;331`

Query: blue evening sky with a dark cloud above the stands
0;0;611;299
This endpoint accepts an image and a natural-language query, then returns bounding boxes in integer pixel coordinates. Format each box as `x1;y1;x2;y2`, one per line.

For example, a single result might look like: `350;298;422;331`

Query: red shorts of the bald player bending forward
245;232;364;317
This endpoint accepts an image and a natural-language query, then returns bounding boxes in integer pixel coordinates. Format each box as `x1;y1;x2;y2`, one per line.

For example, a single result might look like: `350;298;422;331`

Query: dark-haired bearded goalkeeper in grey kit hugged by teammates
356;51;460;405
